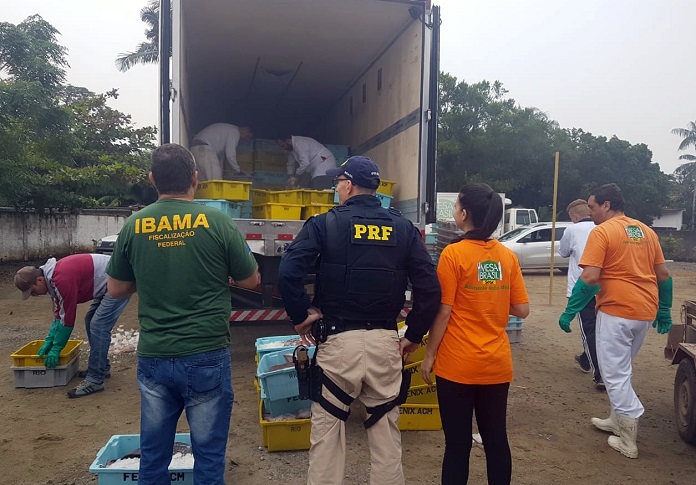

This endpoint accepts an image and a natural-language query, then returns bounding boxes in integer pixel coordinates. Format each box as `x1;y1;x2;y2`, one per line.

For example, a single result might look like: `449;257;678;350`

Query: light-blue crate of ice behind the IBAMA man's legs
89;433;193;485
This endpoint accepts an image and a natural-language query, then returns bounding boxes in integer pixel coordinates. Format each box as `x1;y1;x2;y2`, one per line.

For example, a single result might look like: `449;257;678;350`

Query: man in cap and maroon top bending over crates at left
14;254;130;398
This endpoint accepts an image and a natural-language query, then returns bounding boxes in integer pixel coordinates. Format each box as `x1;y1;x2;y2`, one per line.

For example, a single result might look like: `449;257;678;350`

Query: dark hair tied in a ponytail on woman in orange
457;184;503;241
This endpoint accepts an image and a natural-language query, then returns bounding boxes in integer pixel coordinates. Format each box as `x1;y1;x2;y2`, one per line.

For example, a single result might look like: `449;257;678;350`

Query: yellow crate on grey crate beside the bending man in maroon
10;340;82;389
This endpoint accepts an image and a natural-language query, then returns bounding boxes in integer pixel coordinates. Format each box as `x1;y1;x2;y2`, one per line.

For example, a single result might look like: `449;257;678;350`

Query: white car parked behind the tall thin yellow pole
498;222;572;273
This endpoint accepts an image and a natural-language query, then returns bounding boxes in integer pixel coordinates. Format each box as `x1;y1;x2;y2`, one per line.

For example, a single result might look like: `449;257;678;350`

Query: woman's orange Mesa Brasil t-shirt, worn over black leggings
434;239;529;384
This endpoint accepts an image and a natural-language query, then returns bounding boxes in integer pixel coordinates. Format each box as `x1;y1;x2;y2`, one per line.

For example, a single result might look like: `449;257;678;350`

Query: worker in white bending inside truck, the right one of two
276;136;336;190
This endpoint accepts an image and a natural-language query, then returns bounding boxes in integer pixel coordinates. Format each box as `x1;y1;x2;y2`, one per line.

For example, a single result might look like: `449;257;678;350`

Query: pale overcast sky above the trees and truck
0;0;696;173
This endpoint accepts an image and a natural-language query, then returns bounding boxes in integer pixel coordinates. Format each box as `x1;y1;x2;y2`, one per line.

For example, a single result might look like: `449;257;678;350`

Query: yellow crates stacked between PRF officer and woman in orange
398;322;442;431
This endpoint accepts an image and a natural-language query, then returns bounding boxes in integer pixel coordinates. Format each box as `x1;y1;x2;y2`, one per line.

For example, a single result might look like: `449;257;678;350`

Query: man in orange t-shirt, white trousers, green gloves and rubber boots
559;184;672;458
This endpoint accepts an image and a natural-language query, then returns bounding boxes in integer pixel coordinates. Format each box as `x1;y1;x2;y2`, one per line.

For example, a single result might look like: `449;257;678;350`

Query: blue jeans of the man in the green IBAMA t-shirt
138;347;234;485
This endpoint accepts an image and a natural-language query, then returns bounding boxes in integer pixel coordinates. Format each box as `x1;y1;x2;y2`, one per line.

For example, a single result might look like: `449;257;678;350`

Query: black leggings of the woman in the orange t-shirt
437;377;512;485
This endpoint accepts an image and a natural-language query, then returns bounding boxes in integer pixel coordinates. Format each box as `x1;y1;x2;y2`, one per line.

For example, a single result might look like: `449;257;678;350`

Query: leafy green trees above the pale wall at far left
0;15;155;211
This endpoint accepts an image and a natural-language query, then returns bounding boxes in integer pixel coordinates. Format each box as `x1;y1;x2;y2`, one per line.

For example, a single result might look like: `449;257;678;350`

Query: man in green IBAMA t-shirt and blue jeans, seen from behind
107;144;259;485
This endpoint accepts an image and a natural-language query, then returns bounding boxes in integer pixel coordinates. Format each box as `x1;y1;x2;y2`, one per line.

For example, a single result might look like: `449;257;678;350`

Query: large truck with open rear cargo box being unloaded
160;0;440;321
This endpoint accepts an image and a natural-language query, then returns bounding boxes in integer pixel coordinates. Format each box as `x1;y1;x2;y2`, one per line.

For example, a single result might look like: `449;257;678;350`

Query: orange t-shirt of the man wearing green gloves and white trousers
580;216;665;320
